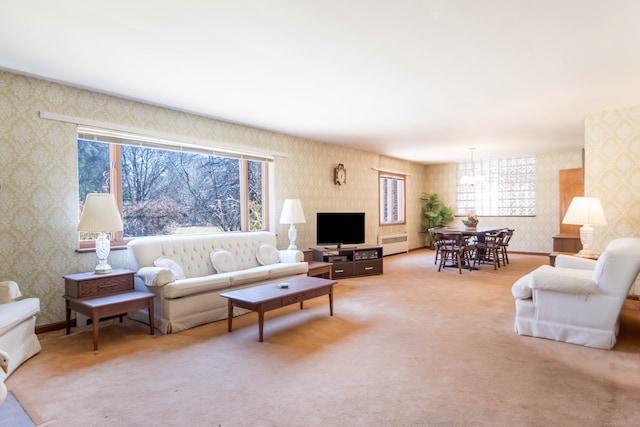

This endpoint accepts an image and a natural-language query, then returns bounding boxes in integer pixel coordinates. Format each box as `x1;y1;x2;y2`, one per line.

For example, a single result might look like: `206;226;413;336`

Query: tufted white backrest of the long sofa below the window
127;231;276;278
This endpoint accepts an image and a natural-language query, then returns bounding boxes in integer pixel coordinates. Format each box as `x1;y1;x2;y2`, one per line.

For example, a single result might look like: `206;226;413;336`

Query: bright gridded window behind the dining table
455;157;536;216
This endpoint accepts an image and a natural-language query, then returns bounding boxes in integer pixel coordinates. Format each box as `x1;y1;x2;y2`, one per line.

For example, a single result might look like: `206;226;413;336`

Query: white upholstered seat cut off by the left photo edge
0;281;40;381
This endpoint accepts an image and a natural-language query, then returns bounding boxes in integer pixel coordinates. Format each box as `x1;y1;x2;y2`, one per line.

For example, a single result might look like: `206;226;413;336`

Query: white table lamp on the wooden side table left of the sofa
78;193;122;274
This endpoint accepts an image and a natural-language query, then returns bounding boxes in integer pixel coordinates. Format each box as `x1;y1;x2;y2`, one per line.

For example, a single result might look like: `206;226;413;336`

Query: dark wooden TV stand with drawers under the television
313;245;382;280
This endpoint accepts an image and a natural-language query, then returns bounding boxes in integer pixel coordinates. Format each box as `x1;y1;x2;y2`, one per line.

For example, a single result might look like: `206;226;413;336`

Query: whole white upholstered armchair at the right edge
511;238;640;349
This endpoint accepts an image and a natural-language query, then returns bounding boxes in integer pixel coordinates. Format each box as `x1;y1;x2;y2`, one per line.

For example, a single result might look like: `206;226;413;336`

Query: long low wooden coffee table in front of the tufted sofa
220;276;338;342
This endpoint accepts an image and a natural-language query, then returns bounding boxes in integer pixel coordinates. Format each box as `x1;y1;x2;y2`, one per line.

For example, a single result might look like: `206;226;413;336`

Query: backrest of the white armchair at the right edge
592;237;640;299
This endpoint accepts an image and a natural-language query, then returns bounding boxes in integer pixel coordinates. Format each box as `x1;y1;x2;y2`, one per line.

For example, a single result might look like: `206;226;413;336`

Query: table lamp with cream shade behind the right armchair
562;197;607;258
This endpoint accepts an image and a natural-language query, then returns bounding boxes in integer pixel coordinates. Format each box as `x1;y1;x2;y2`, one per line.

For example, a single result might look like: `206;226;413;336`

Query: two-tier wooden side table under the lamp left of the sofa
64;270;155;350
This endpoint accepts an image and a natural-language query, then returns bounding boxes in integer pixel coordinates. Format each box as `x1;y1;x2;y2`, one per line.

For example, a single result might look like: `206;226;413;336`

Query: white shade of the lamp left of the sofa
78;193;122;233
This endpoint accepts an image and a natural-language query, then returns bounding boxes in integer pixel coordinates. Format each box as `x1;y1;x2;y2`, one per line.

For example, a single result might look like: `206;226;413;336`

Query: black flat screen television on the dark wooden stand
316;212;365;248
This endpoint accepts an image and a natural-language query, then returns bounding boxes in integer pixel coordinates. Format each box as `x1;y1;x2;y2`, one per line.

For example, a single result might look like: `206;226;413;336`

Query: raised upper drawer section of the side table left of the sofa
65;272;134;298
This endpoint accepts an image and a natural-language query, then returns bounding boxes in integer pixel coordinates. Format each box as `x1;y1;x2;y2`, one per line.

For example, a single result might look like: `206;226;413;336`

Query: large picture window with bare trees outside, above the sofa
78;132;267;247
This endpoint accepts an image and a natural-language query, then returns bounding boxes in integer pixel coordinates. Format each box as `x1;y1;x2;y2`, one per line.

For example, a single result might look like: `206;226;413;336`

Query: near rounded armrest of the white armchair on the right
529;265;596;298
